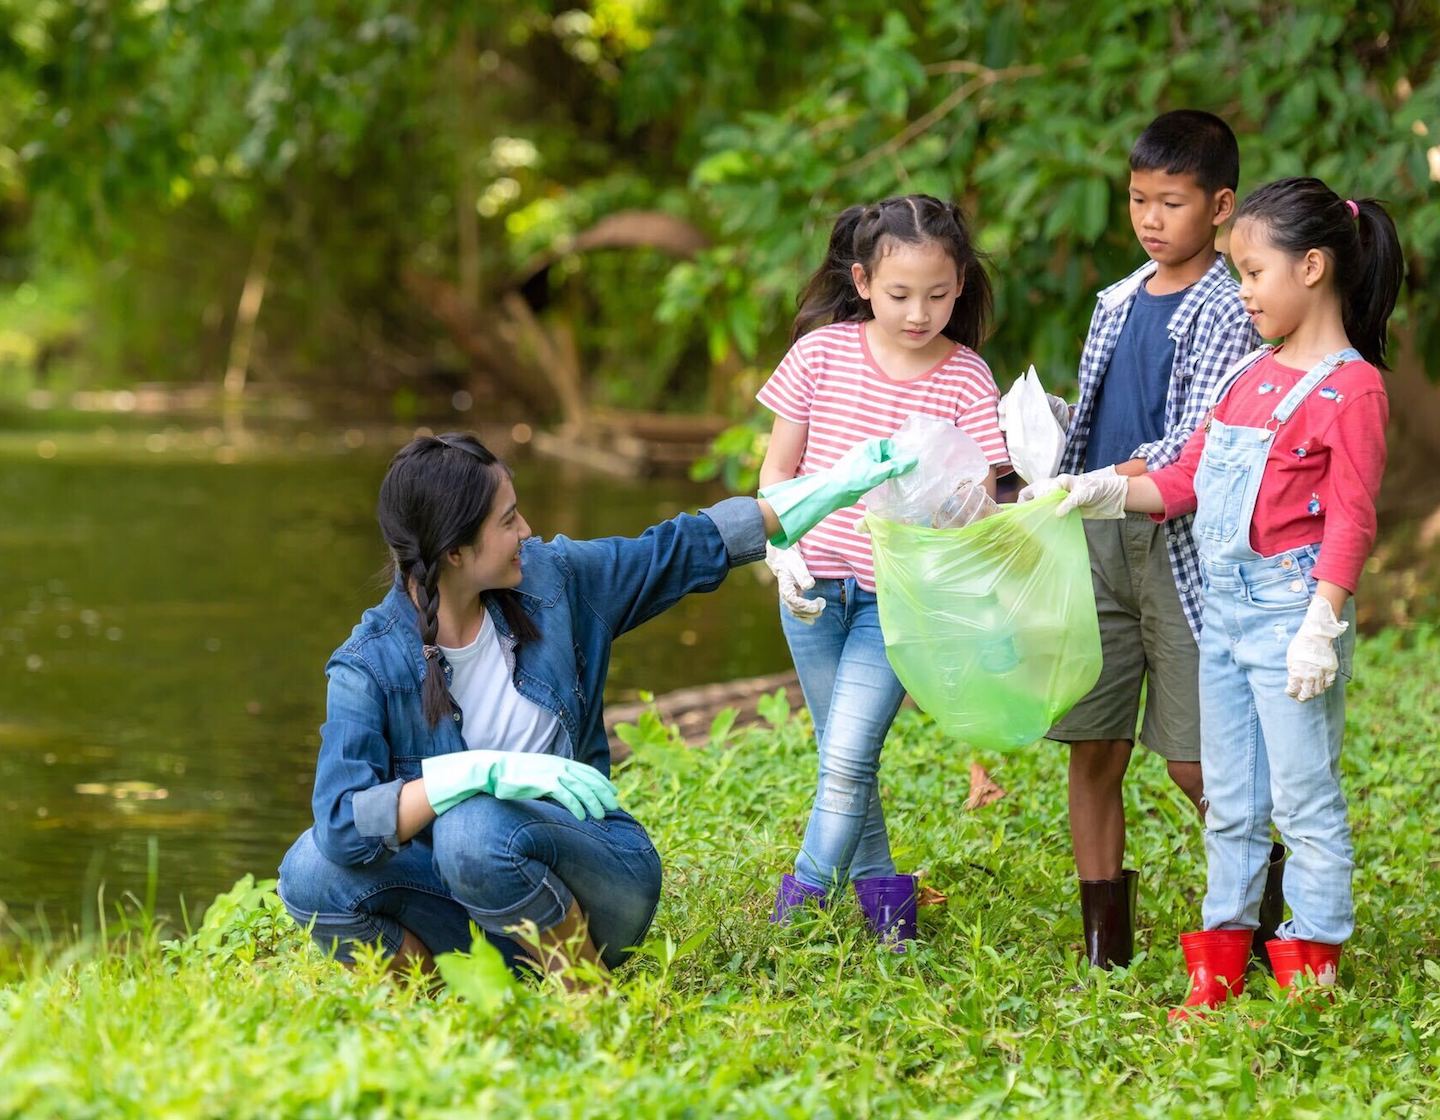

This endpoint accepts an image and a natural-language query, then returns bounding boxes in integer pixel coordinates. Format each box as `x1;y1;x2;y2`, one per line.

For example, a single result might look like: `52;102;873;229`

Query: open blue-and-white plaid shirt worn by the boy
1060;253;1260;639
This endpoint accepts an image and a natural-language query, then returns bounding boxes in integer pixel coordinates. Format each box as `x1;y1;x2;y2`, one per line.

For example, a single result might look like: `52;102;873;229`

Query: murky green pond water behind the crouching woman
0;428;789;927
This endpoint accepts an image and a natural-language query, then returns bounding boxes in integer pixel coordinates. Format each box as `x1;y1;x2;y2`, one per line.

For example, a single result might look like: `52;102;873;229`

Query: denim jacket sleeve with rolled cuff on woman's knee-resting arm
311;654;405;867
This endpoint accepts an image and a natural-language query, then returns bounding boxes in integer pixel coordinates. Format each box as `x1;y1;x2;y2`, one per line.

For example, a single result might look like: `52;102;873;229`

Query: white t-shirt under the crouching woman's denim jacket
441;612;567;754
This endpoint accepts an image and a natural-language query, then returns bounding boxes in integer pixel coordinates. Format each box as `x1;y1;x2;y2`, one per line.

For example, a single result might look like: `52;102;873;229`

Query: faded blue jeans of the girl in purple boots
780;579;904;890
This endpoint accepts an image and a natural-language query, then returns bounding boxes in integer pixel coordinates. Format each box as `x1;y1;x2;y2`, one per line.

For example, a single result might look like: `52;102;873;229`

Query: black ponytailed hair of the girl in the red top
1236;179;1405;370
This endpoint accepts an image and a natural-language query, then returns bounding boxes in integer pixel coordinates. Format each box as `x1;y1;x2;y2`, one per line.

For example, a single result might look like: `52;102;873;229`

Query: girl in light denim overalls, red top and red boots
1036;179;1403;1019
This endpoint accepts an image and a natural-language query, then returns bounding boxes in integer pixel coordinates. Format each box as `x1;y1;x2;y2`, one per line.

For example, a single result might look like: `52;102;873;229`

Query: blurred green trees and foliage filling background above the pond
0;0;1440;449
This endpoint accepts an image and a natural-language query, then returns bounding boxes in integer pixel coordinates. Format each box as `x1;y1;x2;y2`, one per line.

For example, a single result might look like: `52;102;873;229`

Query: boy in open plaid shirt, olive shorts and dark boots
1050;109;1260;969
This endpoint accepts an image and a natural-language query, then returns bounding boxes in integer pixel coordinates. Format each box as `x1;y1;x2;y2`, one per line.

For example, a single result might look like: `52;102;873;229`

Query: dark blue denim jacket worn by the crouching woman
312;498;765;865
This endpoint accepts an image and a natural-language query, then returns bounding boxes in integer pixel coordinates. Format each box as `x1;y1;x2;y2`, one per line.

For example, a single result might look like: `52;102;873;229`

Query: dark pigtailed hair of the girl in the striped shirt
791;194;994;350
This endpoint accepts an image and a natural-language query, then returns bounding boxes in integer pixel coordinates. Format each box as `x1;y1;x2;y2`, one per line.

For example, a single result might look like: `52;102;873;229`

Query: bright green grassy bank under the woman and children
0;628;1440;1117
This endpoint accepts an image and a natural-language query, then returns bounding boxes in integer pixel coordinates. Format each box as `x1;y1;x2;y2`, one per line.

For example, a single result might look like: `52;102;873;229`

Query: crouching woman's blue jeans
279;795;660;969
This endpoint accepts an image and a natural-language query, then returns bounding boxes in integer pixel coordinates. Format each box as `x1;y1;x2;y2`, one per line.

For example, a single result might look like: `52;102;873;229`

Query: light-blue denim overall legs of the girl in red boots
1200;547;1355;944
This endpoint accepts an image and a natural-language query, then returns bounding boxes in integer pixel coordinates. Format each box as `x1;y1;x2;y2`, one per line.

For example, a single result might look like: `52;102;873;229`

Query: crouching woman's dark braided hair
376;432;540;727
